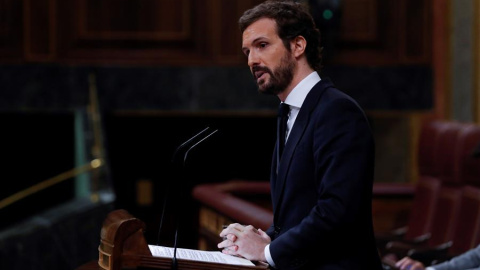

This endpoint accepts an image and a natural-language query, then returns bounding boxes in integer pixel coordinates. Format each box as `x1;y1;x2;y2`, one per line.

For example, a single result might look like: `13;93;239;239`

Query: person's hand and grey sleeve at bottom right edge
395;245;480;270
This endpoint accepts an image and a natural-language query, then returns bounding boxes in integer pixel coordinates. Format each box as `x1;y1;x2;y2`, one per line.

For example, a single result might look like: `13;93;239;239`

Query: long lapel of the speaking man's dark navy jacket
274;78;333;216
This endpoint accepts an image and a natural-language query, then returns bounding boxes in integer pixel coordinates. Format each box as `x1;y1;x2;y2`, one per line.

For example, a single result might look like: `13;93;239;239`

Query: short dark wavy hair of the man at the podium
238;0;322;71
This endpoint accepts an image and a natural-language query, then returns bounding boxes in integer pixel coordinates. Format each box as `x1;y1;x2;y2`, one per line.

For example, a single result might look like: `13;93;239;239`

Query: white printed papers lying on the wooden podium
148;245;255;266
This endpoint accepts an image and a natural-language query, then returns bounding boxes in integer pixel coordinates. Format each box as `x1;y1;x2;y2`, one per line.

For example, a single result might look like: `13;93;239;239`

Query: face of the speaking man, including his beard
242;18;296;95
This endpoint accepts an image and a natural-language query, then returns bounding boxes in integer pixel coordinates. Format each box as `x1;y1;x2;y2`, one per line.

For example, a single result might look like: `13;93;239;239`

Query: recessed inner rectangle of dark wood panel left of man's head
75;0;190;42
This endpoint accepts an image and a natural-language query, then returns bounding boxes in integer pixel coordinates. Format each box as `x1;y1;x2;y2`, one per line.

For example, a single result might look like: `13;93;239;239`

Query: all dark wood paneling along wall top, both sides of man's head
0;0;432;66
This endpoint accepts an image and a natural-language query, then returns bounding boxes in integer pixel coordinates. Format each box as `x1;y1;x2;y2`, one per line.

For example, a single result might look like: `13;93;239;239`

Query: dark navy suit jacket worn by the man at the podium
267;78;382;270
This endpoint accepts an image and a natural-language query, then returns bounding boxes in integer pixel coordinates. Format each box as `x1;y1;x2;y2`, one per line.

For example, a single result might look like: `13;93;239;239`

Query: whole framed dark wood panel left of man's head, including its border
54;0;209;64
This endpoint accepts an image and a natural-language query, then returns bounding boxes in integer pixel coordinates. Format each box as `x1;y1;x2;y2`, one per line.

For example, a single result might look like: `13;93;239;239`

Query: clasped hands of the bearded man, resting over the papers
217;223;271;262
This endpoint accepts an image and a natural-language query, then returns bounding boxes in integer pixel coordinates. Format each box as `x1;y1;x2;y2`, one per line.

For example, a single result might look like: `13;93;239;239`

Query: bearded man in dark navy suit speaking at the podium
218;1;382;270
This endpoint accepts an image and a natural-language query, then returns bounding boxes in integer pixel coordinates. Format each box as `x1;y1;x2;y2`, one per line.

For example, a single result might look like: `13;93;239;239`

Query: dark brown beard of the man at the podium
252;52;296;95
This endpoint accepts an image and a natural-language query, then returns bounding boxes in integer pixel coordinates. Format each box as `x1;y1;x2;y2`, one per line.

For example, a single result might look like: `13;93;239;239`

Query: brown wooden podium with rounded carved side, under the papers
77;209;269;270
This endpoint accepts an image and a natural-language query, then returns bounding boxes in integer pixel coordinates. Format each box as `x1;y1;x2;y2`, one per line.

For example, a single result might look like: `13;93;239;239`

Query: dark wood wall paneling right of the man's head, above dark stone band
333;0;432;65
